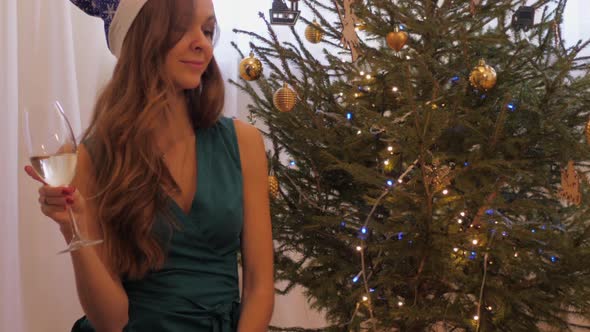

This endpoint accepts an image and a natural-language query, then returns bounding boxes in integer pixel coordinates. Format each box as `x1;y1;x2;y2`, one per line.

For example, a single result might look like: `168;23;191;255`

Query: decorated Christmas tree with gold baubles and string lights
232;0;590;332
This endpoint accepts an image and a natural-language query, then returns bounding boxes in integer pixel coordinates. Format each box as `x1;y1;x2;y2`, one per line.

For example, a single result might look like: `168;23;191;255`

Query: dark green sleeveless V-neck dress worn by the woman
72;117;243;332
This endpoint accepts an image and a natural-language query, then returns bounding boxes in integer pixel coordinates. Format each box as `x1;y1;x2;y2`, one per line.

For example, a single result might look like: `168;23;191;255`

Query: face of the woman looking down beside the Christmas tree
165;0;216;90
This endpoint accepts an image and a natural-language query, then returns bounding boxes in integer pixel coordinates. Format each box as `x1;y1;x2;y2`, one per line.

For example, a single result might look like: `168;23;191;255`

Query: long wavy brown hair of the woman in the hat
82;0;224;279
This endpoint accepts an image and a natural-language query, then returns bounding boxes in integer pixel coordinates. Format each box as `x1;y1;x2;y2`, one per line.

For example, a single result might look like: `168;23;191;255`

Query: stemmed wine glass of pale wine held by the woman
23;101;103;254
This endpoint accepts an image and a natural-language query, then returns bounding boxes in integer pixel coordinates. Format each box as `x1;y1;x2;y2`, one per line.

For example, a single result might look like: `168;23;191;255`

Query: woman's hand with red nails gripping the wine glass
25;166;86;243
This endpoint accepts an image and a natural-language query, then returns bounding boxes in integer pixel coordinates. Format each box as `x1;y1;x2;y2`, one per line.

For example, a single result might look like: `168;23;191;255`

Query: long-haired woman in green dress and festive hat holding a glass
26;0;274;332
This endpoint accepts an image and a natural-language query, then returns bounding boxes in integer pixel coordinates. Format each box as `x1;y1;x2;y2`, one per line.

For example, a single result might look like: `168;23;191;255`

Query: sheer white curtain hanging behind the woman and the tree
0;0;590;332
